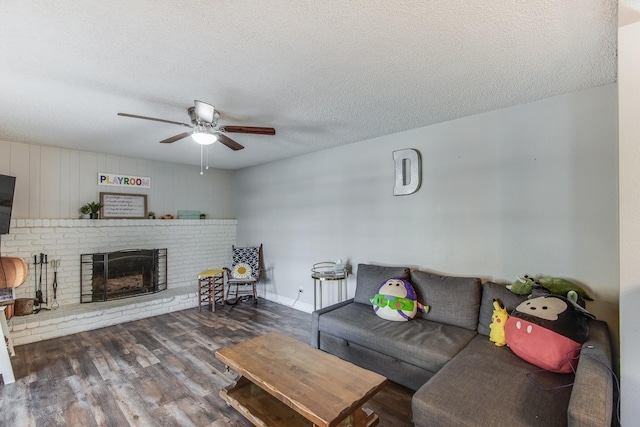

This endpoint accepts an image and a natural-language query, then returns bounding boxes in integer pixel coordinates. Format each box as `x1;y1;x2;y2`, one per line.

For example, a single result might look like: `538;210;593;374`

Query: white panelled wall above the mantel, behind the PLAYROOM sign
0;141;234;219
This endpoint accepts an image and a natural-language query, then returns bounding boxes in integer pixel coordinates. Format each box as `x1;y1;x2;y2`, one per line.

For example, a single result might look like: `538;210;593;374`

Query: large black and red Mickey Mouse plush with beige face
505;295;594;373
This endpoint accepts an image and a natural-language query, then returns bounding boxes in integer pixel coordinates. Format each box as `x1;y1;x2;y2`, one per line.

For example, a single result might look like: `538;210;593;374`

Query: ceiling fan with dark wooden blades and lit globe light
118;100;276;151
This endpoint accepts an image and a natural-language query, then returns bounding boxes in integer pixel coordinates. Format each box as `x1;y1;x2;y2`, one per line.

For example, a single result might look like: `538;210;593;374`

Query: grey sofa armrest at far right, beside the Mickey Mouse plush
567;320;613;427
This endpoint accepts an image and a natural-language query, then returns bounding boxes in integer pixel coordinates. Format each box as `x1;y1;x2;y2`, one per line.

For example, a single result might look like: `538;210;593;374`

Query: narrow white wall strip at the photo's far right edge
618;19;640;425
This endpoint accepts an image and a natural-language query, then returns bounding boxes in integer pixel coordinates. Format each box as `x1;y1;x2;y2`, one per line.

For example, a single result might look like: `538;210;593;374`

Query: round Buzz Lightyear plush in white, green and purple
369;277;429;322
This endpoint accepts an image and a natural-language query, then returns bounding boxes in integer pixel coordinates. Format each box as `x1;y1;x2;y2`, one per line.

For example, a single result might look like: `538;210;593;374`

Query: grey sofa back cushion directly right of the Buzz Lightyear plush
410;271;482;331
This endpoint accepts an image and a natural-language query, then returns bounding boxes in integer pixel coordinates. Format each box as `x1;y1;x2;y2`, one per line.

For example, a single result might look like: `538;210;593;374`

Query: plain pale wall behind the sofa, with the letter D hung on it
234;85;619;336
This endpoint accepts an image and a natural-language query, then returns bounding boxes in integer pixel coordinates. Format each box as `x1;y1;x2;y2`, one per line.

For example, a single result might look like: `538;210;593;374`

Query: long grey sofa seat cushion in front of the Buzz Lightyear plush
319;303;477;372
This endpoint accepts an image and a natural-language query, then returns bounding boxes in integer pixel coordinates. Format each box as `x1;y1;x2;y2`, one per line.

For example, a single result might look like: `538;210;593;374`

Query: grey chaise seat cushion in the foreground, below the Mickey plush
412;335;573;427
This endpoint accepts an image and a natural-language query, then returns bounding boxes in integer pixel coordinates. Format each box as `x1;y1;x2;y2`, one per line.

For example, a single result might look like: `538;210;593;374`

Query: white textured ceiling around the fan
0;0;617;169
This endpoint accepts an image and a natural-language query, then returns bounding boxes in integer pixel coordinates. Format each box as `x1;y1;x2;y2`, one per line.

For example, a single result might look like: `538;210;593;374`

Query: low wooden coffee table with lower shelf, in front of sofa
216;332;387;426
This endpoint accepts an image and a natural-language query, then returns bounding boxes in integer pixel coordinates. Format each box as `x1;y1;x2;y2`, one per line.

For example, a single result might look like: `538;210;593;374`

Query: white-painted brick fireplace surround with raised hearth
2;219;237;345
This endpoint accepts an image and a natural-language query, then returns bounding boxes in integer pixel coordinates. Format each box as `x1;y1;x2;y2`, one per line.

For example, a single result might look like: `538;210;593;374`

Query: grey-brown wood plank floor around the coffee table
0;300;412;427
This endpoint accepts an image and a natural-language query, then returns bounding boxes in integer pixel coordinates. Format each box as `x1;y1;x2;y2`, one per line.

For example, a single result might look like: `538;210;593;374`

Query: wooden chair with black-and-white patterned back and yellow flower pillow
224;244;263;304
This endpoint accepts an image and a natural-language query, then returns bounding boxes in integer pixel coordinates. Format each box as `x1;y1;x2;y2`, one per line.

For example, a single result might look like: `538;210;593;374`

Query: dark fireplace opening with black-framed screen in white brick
80;248;167;303
